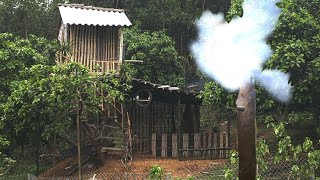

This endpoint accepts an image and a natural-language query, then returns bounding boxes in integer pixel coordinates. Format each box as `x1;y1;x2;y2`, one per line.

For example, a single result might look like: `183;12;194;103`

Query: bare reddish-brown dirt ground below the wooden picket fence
42;154;226;177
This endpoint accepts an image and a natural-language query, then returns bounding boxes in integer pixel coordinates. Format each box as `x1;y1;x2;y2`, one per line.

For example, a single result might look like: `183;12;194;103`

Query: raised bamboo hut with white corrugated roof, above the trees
57;4;131;72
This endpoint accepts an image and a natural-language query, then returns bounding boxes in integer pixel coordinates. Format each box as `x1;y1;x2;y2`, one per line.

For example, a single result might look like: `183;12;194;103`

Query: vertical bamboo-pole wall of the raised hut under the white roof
57;25;123;72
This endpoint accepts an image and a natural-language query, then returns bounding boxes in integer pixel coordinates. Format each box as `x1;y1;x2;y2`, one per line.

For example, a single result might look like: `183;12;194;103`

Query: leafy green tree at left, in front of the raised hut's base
0;34;130;174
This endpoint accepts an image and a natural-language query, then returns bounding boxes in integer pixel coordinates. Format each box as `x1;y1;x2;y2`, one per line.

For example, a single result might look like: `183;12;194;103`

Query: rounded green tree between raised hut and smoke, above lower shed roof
125;25;185;86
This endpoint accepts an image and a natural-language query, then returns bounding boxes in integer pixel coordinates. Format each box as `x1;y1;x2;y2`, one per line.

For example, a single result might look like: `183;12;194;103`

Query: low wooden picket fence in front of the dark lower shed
151;132;230;160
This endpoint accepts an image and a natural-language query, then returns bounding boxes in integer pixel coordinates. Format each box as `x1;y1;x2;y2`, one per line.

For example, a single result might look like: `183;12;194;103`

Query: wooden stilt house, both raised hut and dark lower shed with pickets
57;4;229;158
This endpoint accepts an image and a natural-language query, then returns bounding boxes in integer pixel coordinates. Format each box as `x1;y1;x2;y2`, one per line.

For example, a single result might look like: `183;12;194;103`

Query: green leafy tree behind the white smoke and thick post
202;0;320;126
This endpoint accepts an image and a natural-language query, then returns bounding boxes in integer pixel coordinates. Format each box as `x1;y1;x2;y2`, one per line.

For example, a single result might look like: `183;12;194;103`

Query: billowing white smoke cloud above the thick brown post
191;0;291;102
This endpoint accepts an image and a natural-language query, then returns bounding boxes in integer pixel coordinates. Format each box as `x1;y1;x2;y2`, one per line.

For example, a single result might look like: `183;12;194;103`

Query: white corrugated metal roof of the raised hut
59;4;131;26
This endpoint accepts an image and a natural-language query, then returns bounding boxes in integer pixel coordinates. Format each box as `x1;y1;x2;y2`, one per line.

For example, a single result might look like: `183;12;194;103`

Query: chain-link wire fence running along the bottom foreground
0;159;316;180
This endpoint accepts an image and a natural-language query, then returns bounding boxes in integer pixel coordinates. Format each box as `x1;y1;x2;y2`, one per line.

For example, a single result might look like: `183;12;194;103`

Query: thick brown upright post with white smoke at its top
237;82;257;180
